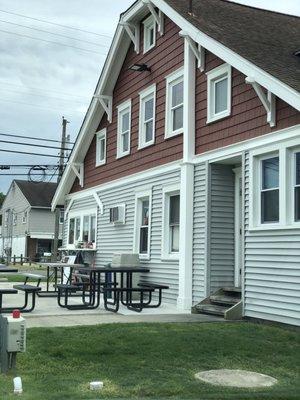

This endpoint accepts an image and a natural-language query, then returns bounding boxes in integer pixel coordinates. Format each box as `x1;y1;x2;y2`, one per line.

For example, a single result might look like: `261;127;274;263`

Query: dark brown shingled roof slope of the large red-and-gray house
165;0;300;92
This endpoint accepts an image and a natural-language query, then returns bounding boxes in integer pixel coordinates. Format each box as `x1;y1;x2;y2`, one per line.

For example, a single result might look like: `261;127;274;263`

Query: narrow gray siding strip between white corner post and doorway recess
192;163;208;304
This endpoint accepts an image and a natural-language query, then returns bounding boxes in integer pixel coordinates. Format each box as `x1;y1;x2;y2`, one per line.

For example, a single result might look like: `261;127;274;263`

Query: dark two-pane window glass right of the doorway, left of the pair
261;157;279;223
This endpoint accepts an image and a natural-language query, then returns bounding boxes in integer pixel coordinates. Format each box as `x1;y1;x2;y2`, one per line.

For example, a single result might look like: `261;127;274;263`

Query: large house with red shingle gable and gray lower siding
52;0;300;325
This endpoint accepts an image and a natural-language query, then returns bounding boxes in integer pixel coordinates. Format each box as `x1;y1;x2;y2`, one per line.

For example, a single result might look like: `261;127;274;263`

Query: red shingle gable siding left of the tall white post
72;18;184;191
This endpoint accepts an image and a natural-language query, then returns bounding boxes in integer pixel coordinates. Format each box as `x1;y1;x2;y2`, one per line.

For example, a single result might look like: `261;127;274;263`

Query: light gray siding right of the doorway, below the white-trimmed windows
244;154;300;325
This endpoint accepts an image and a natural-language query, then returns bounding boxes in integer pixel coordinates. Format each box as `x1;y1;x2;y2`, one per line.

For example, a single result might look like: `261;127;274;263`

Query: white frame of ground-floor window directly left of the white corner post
161;183;180;260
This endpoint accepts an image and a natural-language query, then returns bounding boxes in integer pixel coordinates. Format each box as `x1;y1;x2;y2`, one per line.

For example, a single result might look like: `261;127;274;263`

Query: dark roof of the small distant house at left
14;180;57;208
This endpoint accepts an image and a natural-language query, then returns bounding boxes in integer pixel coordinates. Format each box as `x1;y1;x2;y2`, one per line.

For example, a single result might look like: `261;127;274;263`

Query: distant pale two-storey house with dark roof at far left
1;180;63;260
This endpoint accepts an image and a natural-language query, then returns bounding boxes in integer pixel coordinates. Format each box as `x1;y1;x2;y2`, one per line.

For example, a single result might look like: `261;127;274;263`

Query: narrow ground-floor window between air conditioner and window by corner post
134;191;151;259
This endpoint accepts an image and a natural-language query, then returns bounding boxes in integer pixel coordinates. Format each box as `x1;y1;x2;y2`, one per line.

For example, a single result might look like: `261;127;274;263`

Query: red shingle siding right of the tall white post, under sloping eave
196;52;300;154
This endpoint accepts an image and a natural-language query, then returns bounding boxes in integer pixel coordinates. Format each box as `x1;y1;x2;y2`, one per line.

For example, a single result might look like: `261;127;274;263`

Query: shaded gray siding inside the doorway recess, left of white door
209;164;235;293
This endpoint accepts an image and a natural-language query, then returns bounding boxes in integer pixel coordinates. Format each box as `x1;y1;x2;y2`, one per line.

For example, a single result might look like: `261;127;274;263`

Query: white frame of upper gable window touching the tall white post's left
165;68;184;139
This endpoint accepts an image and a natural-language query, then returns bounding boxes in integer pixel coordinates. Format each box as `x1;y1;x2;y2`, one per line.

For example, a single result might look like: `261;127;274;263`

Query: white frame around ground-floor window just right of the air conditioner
133;189;152;261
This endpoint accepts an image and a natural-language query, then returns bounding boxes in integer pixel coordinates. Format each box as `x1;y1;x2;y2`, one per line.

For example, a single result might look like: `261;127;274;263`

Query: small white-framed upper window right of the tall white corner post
206;64;231;123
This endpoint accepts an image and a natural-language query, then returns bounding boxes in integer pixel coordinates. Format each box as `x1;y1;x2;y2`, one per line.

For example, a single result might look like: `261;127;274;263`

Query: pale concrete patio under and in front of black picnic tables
1;282;224;328
